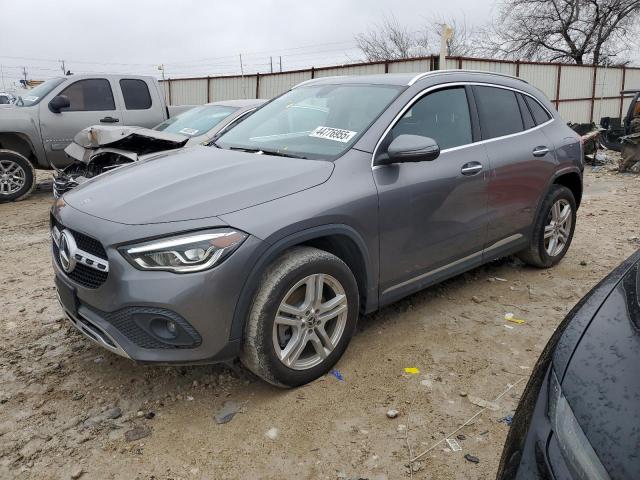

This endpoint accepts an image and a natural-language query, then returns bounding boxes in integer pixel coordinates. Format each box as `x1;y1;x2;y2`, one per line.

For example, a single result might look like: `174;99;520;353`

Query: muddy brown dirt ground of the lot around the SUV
0;167;640;480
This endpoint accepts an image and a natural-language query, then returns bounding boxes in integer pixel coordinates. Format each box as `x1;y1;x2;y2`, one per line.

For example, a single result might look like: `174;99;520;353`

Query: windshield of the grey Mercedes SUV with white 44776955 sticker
216;84;401;159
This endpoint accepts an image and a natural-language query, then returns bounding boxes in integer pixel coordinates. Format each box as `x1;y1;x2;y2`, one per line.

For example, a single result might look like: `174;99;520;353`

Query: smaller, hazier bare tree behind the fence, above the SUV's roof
356;16;429;62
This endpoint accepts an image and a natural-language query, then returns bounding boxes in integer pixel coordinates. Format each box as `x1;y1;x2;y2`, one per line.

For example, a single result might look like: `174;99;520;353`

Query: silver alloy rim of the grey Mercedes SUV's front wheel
272;273;348;370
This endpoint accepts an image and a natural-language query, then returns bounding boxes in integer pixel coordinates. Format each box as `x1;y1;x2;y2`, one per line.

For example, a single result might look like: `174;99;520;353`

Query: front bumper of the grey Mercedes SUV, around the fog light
53;207;261;364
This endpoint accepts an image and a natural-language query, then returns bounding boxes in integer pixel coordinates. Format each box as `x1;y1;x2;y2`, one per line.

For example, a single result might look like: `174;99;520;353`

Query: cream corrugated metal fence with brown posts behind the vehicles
164;57;640;123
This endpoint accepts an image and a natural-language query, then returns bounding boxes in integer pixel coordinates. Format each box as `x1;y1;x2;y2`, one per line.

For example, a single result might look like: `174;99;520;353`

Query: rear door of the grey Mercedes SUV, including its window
473;85;556;254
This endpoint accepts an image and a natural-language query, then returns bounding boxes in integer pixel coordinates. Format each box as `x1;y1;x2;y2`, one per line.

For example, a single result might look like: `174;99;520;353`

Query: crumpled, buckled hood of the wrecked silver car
65;125;189;163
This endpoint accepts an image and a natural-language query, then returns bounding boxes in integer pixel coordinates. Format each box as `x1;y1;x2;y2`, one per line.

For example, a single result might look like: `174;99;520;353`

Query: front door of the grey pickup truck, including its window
40;78;122;166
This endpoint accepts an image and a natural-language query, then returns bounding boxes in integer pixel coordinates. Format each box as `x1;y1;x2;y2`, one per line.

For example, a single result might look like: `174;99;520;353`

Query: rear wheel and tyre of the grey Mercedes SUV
518;185;576;268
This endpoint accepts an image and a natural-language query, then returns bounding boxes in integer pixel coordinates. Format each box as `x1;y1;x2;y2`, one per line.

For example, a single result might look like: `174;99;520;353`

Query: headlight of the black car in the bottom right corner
548;370;610;480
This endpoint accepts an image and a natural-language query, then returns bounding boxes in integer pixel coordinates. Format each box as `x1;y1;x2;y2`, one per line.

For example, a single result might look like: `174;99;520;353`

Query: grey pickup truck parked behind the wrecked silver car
0;75;190;203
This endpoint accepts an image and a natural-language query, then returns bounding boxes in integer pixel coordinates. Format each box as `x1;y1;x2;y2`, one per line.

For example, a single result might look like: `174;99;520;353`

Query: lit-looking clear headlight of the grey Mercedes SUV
120;228;247;273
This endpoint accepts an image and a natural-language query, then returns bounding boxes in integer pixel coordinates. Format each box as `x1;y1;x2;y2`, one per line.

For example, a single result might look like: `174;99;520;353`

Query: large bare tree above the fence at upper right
483;0;640;65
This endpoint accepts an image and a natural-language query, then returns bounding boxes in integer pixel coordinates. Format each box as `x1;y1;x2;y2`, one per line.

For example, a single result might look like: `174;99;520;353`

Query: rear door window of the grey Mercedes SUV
473;86;524;140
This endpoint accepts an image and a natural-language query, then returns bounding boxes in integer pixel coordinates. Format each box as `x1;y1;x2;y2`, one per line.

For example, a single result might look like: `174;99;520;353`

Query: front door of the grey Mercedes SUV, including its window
373;87;489;303
